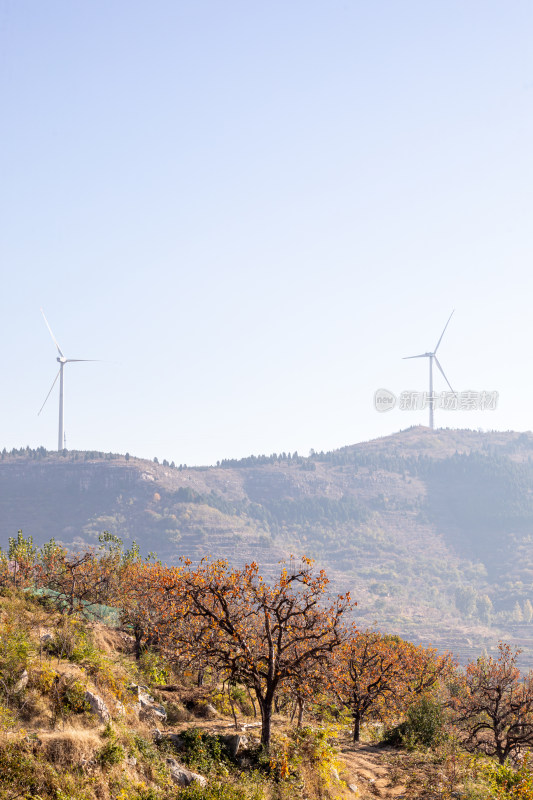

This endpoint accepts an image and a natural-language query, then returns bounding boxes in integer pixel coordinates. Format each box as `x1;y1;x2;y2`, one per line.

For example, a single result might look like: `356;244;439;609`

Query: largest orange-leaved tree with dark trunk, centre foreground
139;558;353;750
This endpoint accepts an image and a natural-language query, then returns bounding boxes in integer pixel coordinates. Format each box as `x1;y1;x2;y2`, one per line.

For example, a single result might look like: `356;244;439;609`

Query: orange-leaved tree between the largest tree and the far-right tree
330;628;451;742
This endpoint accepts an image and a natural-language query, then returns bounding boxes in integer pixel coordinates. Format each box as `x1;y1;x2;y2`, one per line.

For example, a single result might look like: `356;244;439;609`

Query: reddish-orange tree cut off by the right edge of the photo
452;642;533;764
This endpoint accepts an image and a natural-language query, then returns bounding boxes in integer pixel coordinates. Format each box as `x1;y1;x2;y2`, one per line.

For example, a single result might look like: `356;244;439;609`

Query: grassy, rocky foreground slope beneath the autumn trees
0;586;508;800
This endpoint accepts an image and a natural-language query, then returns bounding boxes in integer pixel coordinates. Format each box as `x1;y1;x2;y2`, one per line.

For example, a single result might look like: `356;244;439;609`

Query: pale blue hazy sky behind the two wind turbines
0;0;533;464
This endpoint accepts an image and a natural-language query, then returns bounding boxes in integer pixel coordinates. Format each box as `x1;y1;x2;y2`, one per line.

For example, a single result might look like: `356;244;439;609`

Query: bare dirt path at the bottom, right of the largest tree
337;739;407;800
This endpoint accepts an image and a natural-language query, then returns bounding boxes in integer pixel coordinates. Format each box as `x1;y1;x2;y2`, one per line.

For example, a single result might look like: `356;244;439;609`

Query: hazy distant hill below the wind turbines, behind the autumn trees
0;427;533;668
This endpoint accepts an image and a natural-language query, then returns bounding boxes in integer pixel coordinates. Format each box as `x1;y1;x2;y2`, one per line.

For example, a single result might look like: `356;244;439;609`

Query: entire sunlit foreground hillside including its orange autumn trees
0;534;533;800
